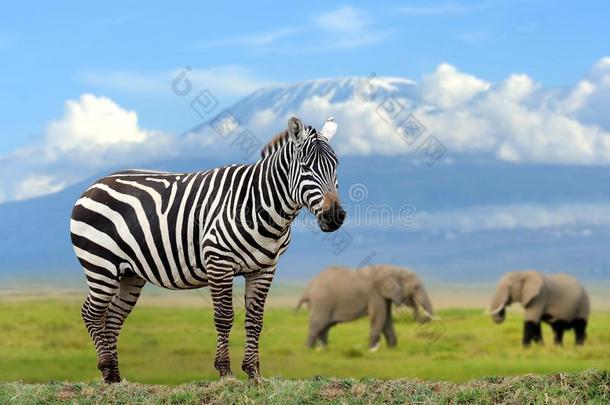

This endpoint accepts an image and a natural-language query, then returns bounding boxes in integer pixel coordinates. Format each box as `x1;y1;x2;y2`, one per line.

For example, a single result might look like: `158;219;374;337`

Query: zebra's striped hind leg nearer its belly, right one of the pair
104;274;146;381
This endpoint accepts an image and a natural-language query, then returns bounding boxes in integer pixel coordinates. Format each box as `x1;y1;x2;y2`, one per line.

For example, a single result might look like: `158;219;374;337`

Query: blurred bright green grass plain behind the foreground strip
0;299;610;384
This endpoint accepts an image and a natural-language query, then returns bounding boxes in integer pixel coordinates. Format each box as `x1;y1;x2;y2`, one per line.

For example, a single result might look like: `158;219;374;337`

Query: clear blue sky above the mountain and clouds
0;1;610;154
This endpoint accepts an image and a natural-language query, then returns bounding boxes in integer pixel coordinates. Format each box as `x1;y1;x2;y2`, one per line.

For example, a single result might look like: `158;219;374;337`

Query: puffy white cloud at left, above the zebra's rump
0;94;184;201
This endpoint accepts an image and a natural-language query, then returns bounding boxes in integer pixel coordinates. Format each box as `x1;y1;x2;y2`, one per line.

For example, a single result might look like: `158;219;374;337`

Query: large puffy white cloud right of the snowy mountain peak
418;60;610;165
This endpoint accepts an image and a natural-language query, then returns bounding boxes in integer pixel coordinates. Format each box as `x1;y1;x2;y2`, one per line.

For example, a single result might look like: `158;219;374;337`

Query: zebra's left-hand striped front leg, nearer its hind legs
208;268;233;377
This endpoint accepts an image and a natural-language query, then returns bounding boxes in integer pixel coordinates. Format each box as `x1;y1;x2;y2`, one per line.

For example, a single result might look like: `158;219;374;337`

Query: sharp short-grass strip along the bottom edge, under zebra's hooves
0;370;610;405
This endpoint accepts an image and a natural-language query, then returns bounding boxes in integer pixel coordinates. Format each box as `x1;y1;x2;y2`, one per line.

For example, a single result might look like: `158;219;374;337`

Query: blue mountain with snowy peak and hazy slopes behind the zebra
0;78;610;282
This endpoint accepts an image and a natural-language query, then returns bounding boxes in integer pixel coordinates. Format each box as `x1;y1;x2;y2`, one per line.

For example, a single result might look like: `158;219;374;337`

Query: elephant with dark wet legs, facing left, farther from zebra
489;270;589;346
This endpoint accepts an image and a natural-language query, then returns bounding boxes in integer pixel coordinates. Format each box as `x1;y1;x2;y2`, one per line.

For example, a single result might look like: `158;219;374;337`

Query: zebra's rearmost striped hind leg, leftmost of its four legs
81;278;120;383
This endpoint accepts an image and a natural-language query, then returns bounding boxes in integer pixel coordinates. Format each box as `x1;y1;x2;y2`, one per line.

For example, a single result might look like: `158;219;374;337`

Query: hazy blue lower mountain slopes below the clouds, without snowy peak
0;157;610;281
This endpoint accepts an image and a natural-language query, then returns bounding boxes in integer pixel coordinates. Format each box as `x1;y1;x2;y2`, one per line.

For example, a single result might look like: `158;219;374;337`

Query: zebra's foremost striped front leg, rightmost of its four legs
241;268;275;379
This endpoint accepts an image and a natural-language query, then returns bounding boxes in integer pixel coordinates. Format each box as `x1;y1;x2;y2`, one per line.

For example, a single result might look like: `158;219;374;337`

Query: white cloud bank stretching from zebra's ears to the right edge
270;58;610;165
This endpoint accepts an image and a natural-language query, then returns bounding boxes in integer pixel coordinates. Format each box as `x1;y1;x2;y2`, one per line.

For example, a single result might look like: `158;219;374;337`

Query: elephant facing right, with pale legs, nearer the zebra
297;265;433;350
